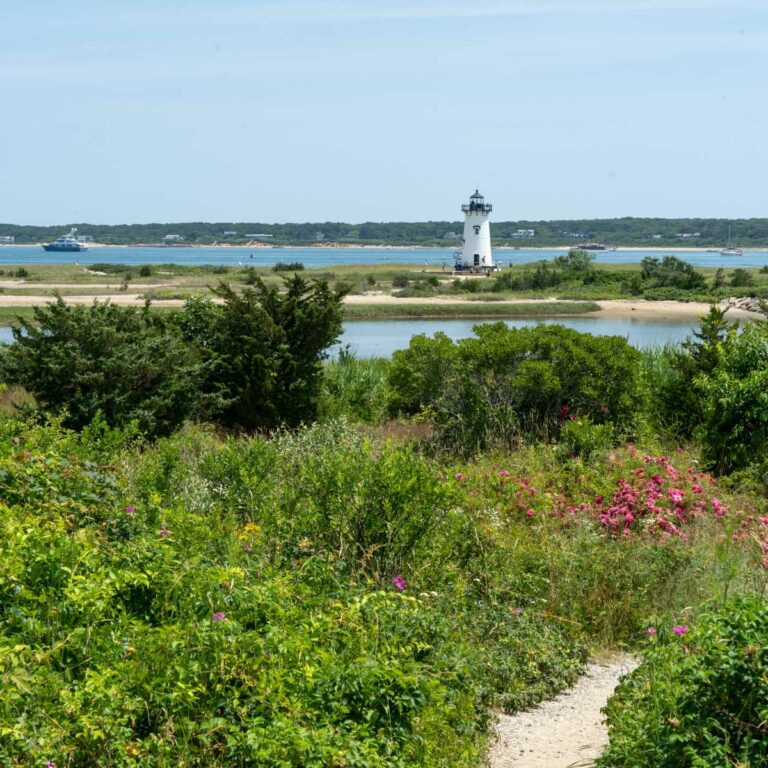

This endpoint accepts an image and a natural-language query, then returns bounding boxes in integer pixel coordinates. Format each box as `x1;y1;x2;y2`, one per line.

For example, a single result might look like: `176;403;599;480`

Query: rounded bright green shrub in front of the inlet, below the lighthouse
389;323;640;452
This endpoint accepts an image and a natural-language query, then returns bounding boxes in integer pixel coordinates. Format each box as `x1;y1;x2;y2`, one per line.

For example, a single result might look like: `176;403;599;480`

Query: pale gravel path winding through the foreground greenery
490;656;637;768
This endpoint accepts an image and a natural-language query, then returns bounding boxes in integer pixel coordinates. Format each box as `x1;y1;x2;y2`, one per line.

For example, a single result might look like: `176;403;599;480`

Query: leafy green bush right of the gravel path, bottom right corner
597;598;768;768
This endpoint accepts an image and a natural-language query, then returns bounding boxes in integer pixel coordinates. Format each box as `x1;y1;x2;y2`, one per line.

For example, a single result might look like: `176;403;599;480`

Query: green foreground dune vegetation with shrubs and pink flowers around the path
0;275;768;768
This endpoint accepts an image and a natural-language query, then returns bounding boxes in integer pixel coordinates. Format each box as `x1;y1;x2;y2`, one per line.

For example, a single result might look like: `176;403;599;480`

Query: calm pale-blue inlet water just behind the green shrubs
0;317;696;357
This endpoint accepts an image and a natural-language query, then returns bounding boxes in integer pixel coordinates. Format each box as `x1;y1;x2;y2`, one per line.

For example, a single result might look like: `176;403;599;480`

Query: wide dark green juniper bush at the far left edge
2;298;204;436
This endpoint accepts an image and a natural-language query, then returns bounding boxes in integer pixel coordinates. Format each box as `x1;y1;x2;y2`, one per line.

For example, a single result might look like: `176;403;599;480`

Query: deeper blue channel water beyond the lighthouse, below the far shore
0;245;768;269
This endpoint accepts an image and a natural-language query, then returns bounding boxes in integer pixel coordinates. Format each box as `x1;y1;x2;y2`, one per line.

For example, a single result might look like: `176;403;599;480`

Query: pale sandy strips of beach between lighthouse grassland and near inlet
0;292;761;320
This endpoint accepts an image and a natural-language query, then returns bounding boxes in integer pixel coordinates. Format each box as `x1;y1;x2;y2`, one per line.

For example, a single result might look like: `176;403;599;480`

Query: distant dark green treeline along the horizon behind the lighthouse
0;217;768;248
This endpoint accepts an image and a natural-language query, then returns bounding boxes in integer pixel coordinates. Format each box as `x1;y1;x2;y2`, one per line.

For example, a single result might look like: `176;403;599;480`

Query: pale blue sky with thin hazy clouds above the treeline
0;0;768;225
